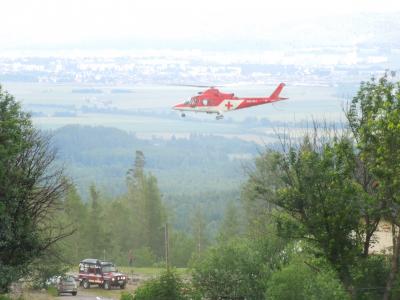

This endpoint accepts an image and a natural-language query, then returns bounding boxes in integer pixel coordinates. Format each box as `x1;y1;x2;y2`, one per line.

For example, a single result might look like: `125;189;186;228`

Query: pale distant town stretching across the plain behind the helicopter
0;45;400;86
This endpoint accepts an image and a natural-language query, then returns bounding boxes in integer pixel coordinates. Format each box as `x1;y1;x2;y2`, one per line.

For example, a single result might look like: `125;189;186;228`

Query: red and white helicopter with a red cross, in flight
172;83;288;120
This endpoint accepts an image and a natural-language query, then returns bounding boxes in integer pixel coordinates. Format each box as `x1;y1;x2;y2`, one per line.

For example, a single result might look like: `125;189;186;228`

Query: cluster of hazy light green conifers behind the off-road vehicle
53;153;170;267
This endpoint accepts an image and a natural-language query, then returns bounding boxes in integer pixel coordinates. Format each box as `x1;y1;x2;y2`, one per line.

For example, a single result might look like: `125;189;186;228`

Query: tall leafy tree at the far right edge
347;73;400;299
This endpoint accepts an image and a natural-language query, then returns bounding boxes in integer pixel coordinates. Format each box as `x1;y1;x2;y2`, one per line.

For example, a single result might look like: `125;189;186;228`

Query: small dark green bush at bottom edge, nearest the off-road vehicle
134;270;187;300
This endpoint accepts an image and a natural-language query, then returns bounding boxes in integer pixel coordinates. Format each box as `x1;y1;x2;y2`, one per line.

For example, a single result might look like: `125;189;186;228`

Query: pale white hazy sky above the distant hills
0;0;400;49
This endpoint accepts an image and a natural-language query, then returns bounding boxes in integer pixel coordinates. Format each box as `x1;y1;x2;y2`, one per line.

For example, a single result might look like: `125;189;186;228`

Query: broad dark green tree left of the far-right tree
245;133;374;291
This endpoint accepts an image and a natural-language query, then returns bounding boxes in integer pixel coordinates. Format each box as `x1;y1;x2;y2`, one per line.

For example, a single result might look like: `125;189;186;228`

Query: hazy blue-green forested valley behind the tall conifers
49;125;263;233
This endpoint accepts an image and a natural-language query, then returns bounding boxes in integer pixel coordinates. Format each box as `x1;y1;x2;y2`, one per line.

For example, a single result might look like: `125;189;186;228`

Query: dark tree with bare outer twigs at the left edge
0;86;70;292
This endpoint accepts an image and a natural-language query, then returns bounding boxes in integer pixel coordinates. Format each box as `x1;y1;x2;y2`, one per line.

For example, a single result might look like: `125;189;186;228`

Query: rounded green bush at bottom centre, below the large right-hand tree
193;239;267;299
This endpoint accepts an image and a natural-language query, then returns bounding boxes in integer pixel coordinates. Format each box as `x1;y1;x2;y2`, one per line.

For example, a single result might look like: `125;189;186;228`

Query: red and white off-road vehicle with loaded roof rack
79;258;128;290
